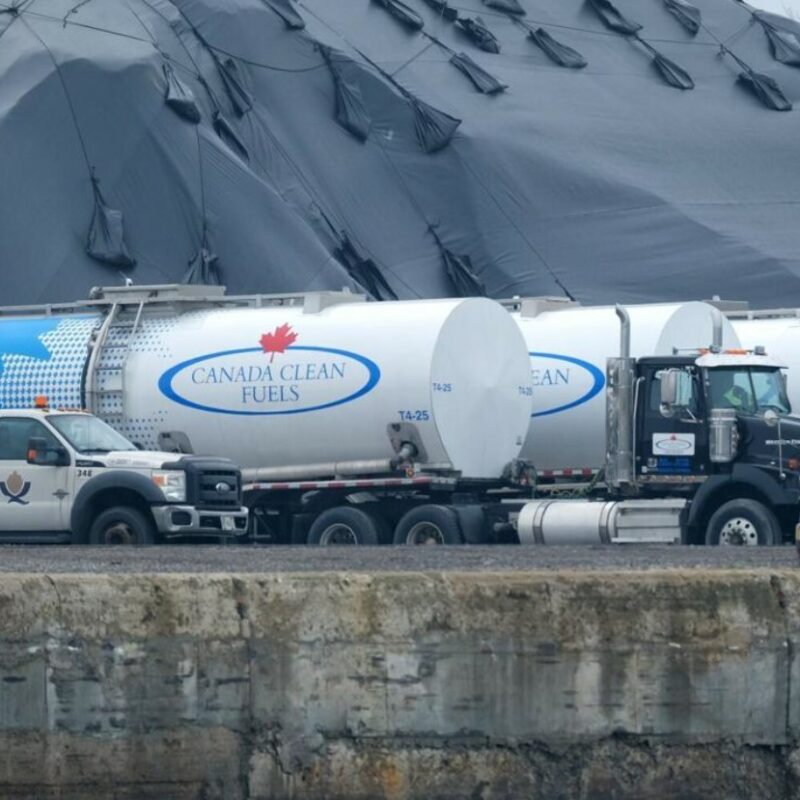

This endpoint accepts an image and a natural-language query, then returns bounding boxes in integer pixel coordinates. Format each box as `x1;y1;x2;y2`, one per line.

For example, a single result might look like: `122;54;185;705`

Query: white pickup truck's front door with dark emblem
0;417;72;533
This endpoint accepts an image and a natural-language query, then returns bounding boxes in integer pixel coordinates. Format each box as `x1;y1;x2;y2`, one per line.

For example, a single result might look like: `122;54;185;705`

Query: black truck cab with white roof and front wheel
633;350;800;545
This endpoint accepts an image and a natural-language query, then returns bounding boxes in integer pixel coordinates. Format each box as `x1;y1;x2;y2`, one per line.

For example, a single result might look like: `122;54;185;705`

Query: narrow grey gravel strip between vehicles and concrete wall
0;544;800;573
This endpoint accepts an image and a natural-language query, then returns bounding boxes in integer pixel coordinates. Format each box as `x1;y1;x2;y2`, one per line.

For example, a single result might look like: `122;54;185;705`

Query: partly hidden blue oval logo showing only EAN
528;352;606;417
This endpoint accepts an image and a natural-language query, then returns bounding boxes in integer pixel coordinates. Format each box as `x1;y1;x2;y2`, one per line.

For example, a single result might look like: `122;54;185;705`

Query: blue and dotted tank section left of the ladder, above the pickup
0;315;98;408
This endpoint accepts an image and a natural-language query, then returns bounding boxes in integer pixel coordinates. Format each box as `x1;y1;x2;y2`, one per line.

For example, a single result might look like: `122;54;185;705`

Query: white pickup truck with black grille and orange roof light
0;398;248;544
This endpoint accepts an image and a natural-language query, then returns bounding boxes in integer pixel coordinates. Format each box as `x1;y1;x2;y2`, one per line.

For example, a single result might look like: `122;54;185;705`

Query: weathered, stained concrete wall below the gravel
0;570;800;800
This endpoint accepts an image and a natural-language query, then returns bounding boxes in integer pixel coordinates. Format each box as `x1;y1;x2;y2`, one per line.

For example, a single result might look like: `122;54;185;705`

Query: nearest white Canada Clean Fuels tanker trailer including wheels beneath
0;286;532;544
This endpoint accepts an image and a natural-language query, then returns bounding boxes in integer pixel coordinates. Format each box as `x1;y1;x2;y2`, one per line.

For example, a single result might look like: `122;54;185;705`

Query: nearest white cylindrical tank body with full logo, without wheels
0;298;531;478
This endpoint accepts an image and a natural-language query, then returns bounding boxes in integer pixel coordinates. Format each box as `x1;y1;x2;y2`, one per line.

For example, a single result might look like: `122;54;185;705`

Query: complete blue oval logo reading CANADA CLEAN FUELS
158;345;381;417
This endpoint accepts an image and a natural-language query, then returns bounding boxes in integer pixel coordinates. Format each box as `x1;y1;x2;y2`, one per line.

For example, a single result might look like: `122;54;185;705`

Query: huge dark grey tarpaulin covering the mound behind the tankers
0;0;800;306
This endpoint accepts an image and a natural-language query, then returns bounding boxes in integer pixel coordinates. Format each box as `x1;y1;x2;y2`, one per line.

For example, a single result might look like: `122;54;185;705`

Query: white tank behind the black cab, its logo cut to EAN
511;301;739;474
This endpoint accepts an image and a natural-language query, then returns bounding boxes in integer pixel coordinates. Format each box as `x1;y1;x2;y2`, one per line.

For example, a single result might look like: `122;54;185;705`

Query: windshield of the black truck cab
707;367;791;414
